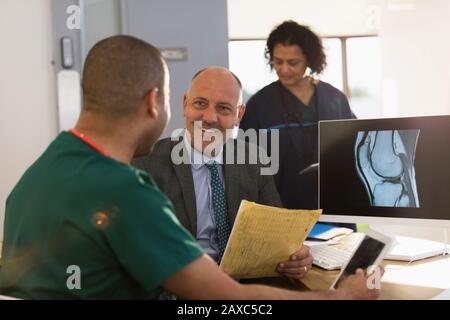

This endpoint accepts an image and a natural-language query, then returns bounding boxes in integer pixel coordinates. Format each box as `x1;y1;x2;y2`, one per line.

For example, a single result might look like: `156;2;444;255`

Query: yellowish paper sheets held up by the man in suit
220;200;322;279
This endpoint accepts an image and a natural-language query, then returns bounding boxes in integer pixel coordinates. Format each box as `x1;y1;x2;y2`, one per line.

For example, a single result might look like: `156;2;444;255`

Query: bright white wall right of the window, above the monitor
379;0;450;116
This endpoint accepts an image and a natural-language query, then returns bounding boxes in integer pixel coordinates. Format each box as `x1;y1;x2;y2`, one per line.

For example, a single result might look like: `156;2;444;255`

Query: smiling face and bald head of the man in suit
183;67;245;152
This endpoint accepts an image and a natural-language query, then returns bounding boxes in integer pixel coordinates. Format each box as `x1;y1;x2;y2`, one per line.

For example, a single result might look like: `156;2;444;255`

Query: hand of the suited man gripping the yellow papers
277;246;313;279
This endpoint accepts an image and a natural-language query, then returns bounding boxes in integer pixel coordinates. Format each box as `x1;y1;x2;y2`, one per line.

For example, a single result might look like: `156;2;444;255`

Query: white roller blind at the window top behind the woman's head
228;0;374;38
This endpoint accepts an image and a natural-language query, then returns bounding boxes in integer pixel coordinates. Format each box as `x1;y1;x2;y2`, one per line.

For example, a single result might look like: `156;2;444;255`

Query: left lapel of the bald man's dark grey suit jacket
171;141;197;236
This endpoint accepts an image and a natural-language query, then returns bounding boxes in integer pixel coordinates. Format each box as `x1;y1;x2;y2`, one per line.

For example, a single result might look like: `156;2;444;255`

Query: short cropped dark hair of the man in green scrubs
82;35;165;116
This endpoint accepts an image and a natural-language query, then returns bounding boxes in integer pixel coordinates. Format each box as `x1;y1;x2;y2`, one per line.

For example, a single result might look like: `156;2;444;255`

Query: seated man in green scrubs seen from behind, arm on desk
0;36;379;299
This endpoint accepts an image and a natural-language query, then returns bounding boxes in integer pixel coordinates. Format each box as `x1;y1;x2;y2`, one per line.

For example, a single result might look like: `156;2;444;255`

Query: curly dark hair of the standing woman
265;20;327;74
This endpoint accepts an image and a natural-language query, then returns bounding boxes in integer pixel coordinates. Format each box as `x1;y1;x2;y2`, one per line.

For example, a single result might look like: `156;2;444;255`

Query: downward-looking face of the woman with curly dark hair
272;43;308;87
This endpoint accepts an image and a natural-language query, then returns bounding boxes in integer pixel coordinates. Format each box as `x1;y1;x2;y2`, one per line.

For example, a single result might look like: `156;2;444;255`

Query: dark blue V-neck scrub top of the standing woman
240;81;355;209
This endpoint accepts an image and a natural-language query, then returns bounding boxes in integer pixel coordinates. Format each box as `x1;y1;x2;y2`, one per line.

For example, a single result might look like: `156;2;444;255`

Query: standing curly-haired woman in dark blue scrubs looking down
240;21;355;214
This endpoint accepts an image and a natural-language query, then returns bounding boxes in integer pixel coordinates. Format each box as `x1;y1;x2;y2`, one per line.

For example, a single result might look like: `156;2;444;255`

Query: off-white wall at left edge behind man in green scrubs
0;0;57;244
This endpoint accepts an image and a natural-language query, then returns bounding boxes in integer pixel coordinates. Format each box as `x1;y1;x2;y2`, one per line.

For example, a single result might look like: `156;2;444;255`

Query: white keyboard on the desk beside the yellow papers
311;245;353;270
